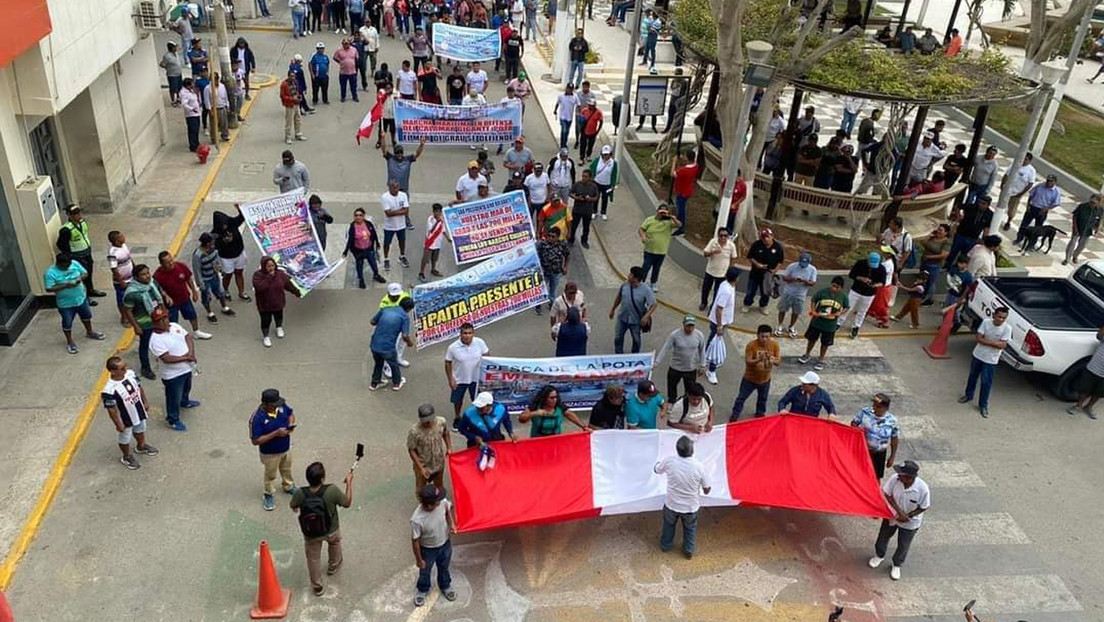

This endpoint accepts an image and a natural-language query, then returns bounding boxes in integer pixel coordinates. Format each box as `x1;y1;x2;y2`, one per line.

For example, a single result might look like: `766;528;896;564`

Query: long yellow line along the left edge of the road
0;76;276;590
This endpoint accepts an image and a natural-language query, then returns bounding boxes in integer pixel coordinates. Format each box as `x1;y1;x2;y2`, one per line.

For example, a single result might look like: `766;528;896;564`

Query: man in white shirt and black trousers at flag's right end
870;460;932;581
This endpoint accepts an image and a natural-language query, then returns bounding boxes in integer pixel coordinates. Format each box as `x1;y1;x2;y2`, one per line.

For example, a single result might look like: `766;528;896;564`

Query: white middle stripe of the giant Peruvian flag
591;426;736;515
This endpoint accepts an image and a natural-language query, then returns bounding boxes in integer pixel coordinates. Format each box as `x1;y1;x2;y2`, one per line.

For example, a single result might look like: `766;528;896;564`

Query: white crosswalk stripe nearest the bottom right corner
869;572;1082;618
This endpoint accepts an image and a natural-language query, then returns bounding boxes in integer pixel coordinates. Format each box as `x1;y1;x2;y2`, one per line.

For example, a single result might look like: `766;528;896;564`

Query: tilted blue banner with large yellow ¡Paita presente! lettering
414;243;548;349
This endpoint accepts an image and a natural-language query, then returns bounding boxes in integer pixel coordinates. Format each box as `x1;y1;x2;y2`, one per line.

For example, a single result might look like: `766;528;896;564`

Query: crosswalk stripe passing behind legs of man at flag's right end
829;510;1031;548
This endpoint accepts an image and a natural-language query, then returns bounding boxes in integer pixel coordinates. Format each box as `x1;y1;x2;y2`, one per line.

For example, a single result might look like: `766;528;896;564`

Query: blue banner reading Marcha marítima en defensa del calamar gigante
395;99;521;145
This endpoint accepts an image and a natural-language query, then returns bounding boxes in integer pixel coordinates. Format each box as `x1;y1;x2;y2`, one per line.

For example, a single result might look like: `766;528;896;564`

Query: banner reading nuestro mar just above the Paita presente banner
444;190;535;264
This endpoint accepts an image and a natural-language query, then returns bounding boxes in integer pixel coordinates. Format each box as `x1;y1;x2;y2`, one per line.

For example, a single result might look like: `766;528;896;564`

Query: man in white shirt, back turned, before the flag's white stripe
654;436;710;559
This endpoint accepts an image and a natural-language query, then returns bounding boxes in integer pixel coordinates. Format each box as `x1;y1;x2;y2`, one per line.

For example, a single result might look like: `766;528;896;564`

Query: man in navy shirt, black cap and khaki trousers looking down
250;389;299;512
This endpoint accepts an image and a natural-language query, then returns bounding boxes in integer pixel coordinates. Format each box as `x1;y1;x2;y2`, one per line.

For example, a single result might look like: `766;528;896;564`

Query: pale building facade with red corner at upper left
0;0;167;345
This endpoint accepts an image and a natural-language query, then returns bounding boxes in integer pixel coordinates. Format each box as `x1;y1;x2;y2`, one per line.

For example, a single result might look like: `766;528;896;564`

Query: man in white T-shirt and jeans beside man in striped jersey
149;307;200;432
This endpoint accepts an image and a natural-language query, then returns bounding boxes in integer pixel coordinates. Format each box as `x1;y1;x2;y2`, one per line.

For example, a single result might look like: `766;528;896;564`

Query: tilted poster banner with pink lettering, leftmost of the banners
241;188;341;294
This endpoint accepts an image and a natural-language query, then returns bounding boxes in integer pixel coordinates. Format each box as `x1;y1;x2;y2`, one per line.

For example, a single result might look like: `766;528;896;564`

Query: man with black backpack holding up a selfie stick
290;462;352;597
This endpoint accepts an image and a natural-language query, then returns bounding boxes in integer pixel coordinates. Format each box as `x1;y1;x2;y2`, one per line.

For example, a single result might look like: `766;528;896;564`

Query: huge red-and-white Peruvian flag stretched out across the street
448;414;891;531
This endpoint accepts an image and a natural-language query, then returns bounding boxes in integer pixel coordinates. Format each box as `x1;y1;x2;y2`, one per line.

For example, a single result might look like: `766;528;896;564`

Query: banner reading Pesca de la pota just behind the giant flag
479;352;655;412
